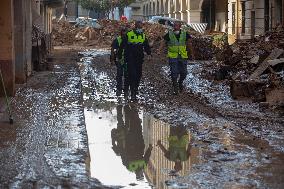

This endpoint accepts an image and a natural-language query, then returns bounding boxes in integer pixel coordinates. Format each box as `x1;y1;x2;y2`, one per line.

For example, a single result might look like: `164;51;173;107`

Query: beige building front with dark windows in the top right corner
228;0;284;43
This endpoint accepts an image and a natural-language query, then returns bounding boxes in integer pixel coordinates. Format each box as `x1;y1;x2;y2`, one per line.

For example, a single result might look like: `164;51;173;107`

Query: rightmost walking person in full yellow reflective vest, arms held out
158;22;194;95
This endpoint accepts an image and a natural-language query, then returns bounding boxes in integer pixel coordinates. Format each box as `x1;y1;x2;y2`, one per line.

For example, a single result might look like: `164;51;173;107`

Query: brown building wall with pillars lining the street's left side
0;0;63;96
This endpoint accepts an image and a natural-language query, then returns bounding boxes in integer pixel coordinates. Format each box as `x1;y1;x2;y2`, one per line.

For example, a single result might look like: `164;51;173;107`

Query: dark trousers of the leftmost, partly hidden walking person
116;62;129;92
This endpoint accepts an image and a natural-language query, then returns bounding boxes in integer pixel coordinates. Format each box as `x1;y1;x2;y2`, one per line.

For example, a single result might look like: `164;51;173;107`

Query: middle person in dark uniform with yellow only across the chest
119;21;151;101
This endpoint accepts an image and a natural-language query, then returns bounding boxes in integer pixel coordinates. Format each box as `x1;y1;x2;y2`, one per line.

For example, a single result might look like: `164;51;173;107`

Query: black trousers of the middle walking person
127;60;143;96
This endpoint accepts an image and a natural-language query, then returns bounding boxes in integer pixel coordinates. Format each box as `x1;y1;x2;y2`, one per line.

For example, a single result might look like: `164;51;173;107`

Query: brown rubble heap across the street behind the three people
53;19;213;60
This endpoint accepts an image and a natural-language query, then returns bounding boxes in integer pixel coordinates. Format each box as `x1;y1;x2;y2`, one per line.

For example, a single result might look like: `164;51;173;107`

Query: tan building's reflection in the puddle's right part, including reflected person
143;115;199;188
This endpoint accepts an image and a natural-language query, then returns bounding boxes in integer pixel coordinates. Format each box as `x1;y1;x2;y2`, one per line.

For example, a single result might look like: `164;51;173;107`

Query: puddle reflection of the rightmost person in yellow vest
157;126;191;172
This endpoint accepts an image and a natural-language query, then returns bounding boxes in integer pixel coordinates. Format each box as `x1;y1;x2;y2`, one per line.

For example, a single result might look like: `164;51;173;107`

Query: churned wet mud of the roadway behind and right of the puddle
80;50;284;188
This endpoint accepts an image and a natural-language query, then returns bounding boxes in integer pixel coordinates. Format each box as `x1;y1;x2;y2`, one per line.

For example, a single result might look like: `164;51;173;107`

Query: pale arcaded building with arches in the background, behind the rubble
130;0;228;32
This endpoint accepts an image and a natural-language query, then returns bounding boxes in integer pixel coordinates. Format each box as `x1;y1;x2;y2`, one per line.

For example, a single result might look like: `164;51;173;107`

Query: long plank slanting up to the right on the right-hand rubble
248;48;284;79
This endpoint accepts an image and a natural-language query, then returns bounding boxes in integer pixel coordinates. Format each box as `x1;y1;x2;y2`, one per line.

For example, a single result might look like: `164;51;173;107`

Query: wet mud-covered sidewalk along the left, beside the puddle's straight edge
0;50;108;188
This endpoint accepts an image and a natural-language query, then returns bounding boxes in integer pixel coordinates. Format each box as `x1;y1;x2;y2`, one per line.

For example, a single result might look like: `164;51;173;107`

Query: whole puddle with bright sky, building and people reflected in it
85;104;198;188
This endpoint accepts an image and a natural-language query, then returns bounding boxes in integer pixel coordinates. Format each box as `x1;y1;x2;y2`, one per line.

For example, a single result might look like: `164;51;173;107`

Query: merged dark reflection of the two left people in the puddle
111;105;152;179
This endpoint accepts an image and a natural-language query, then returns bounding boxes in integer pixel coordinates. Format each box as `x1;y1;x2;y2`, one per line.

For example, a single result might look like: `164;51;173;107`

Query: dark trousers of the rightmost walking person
169;58;187;84
